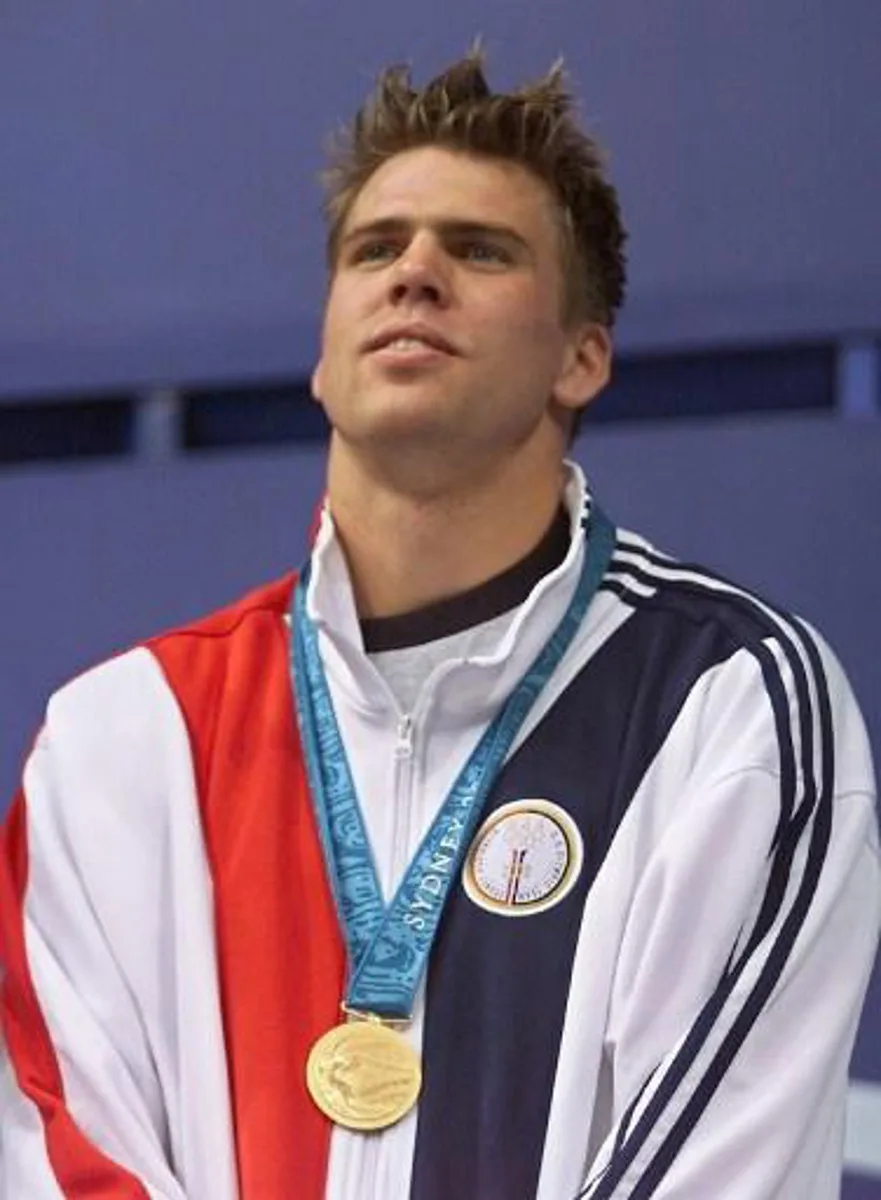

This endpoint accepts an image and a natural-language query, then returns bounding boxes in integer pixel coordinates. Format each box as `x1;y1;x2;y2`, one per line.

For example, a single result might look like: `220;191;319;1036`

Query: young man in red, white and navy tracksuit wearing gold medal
0;55;881;1200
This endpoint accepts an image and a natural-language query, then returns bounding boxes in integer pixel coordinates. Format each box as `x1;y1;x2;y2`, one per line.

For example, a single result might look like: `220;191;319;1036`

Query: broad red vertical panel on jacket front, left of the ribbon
149;576;344;1200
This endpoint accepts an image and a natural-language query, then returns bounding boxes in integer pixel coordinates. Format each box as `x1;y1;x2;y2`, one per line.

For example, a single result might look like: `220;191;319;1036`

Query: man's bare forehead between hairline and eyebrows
346;146;555;244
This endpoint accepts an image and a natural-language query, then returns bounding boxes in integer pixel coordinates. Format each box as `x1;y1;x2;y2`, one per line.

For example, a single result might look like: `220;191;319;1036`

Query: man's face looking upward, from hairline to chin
313;146;607;463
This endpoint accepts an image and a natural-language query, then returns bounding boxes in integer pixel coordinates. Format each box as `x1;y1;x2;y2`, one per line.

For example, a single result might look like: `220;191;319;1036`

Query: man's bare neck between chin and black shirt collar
328;442;563;618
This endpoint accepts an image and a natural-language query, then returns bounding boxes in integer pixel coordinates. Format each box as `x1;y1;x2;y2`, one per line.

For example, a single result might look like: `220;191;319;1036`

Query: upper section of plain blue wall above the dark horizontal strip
0;0;881;391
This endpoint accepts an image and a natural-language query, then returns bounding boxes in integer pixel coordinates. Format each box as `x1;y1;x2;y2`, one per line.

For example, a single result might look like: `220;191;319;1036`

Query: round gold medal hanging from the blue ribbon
306;1016;422;1129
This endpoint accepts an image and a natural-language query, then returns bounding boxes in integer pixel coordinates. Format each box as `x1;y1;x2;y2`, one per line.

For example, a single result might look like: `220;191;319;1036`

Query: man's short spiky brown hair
322;44;627;328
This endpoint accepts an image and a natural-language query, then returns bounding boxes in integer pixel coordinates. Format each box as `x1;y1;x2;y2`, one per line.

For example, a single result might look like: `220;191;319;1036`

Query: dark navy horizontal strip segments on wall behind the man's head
0;342;837;463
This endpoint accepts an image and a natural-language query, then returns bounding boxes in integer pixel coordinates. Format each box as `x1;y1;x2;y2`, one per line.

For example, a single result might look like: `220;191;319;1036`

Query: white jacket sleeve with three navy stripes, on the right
579;625;881;1200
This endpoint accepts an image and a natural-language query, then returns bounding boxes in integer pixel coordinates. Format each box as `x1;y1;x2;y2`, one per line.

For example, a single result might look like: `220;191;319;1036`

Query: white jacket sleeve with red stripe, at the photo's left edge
0;652;220;1200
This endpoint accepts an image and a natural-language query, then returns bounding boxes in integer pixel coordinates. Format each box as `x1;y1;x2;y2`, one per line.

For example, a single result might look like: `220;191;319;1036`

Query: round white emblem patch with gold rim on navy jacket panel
462;799;585;917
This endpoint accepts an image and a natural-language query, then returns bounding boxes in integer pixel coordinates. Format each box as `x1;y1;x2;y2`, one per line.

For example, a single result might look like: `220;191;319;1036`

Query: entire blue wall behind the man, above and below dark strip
0;0;881;1200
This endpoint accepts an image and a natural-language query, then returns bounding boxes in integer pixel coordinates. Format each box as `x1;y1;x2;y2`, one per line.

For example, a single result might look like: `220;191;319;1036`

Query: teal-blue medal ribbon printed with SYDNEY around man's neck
292;504;615;1019
